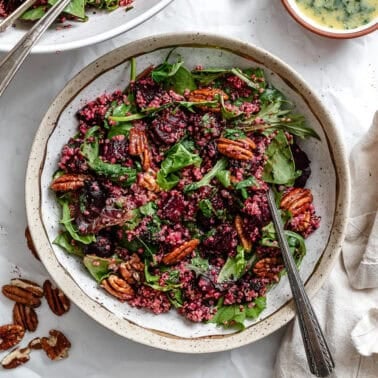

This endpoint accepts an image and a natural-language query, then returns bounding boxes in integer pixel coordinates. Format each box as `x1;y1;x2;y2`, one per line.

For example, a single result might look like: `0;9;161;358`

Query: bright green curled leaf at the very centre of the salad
156;143;202;190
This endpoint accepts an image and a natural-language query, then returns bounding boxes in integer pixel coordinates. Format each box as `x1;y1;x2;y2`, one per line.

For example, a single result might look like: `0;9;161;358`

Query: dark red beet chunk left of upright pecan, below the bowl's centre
203;223;238;255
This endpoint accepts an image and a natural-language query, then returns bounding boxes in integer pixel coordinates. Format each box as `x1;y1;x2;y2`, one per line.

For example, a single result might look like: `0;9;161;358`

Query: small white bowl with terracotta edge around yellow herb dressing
282;0;378;39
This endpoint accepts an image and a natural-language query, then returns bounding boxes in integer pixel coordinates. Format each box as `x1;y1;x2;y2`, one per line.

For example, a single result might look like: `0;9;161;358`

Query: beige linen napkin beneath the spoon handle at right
275;112;378;378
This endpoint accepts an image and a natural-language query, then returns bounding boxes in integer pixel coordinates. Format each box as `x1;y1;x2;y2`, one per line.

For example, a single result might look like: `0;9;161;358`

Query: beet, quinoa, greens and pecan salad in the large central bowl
51;53;320;330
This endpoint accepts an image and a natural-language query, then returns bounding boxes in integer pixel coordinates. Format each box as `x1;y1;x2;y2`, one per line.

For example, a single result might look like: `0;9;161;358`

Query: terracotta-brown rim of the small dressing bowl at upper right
281;0;378;39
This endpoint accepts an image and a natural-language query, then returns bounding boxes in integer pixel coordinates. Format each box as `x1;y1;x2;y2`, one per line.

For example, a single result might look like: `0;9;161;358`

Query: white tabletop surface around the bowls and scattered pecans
0;0;378;378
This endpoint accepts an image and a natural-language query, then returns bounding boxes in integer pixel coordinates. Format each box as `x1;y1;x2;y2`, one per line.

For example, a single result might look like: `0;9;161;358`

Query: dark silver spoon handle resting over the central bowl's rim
268;189;335;377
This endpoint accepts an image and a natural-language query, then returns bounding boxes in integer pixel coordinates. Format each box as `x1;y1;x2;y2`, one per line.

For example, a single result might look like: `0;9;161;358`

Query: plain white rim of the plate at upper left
0;0;173;54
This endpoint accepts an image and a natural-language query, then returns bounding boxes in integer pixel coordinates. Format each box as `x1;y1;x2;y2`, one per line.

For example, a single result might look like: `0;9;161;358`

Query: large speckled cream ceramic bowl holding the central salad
26;33;349;353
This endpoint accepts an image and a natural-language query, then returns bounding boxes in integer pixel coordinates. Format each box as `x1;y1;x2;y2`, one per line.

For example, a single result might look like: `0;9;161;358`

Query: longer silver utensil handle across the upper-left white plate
0;0;71;96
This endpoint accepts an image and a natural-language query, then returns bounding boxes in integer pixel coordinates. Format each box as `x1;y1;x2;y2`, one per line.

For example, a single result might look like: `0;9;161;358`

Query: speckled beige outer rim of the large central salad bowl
25;32;350;353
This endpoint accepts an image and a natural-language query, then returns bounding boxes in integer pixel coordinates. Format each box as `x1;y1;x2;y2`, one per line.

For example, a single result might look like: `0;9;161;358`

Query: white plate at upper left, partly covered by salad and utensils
0;0;173;53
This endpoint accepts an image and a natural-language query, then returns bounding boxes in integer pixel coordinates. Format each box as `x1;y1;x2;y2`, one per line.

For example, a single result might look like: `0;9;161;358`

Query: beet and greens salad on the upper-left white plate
0;0;134;22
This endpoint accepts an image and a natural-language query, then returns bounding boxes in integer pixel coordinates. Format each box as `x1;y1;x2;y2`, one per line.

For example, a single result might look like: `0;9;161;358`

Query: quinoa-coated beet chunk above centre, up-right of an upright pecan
151;110;187;145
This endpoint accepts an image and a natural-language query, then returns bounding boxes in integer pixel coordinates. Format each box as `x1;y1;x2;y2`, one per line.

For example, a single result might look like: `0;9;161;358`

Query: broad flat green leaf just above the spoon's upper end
262;130;297;186
